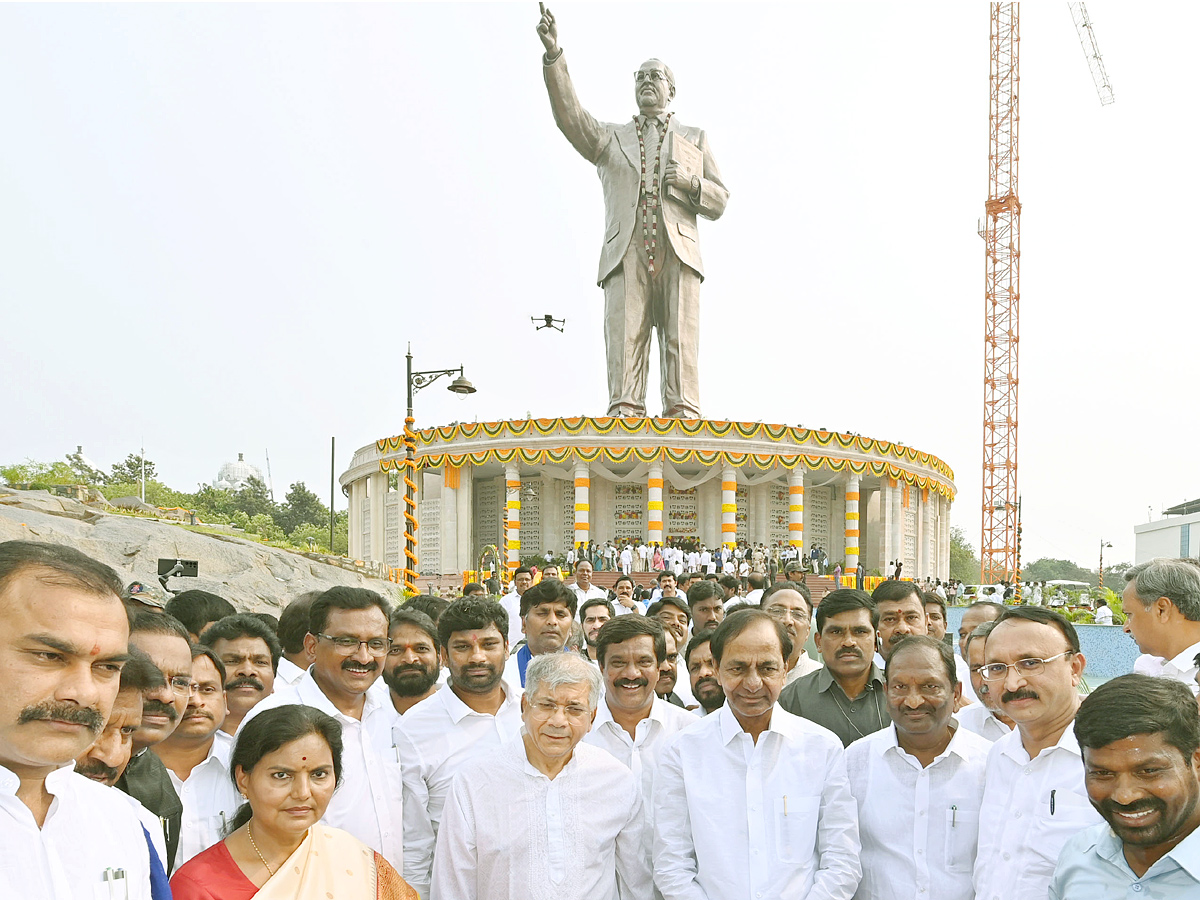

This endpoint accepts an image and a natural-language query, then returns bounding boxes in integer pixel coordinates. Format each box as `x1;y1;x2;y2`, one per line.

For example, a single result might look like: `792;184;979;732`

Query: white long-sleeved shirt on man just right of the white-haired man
654;704;863;900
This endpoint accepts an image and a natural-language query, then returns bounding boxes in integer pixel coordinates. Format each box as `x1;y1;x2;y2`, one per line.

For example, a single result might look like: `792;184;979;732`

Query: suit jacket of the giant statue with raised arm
542;52;730;284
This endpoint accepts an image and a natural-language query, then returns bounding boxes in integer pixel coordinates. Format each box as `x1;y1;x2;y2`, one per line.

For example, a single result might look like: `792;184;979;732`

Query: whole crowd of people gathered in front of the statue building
0;541;1200;900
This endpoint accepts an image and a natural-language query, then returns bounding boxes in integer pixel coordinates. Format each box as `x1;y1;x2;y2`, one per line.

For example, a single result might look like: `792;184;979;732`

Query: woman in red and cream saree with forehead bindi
170;706;418;900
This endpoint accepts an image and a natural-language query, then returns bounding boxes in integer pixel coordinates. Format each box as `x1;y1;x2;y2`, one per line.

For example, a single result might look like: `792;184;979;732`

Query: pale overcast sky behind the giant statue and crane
0;2;1200;568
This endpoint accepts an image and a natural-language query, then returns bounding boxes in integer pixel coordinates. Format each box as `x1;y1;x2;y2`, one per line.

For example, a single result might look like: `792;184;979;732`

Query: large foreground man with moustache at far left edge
0;541;151;900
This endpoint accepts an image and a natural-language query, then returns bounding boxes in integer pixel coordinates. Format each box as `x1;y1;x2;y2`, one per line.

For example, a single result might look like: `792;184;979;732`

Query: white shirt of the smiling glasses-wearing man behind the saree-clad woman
238;670;408;883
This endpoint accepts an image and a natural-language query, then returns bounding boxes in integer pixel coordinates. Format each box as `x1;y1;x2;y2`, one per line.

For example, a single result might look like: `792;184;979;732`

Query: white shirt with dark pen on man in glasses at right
974;725;1103;900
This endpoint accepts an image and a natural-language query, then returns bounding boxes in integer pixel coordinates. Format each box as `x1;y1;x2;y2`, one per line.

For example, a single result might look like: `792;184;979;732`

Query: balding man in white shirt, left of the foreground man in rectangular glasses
846;635;991;900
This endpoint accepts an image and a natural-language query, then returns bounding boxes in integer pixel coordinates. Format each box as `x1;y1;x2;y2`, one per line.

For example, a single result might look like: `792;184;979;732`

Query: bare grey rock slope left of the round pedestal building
0;486;400;614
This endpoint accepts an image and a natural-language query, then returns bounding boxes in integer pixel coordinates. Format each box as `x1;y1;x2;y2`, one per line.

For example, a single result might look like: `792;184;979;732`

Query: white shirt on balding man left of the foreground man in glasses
846;725;991;900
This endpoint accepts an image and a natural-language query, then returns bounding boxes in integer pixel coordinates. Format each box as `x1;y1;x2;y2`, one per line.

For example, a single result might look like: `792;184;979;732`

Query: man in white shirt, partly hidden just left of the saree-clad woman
151;644;241;869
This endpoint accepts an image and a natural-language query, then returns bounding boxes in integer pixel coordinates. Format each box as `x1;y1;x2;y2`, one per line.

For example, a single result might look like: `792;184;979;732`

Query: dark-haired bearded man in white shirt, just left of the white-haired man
392;596;521;884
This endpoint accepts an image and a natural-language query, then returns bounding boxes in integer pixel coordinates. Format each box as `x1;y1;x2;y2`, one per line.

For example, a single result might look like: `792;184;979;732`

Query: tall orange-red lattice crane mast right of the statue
979;2;1021;584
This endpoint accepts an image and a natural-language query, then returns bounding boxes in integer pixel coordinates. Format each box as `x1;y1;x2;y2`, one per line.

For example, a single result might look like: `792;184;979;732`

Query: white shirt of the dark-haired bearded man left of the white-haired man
392;684;521;884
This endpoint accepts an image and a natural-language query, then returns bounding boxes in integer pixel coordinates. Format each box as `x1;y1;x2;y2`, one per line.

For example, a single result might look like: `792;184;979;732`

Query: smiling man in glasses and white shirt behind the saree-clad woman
238;587;410;895
